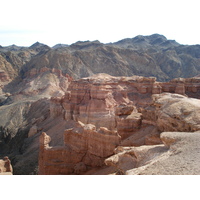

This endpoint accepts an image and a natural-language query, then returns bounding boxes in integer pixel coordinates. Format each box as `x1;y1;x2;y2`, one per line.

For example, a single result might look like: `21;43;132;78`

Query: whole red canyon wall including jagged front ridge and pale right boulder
39;74;200;174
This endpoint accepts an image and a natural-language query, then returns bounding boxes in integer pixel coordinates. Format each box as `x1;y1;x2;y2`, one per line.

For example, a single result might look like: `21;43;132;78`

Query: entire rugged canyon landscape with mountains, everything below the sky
0;34;200;175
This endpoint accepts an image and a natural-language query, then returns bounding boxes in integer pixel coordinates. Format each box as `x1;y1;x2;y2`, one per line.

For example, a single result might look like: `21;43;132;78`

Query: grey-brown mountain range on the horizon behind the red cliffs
0;34;200;84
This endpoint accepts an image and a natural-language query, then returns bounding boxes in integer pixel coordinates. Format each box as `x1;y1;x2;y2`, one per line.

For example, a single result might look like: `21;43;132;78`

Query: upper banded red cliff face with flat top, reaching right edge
47;74;200;130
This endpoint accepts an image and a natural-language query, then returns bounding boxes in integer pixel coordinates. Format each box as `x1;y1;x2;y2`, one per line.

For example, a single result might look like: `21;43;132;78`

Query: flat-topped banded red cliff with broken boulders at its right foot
50;74;199;135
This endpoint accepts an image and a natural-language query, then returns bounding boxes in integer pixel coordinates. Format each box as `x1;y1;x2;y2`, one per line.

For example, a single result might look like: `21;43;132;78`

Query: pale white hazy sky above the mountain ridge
0;0;200;46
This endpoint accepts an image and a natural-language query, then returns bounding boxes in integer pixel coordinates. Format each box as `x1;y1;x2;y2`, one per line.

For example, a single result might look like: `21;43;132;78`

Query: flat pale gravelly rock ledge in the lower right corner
126;132;200;175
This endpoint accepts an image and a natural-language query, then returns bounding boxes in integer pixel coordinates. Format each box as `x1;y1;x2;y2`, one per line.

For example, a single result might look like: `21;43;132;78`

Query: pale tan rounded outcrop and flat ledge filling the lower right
105;93;200;174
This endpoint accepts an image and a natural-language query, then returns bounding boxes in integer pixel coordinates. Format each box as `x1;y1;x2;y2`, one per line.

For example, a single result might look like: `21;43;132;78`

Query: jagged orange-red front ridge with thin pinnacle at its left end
39;122;120;174
